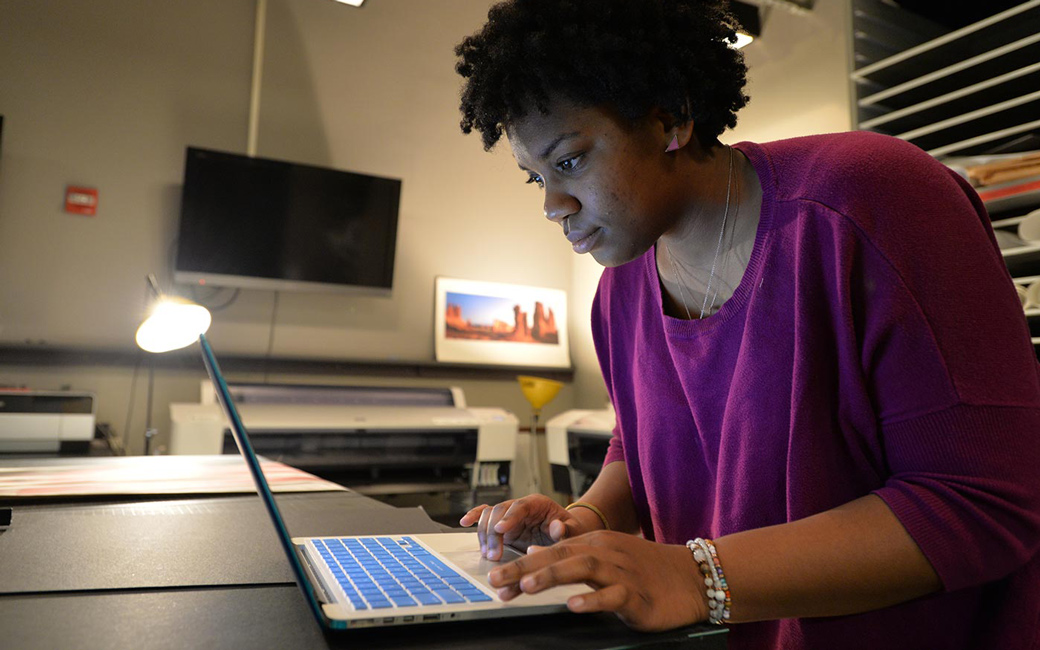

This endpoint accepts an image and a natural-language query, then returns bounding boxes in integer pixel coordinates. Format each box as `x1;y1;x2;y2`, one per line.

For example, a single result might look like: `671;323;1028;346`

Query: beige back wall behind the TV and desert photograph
0;0;849;449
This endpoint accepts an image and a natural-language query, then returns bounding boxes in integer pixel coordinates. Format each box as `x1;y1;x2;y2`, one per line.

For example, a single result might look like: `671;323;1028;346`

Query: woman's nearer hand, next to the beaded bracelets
488;530;707;631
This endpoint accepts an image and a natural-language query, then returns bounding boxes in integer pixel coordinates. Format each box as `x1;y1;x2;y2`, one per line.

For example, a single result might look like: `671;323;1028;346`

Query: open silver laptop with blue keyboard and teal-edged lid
199;335;590;630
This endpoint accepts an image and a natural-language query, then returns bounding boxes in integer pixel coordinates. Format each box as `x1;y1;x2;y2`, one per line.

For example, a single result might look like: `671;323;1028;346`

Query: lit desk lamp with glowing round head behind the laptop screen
136;274;212;456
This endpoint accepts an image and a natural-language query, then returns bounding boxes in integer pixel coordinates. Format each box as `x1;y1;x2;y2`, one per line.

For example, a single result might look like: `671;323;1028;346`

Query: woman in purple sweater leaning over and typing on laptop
457;0;1040;650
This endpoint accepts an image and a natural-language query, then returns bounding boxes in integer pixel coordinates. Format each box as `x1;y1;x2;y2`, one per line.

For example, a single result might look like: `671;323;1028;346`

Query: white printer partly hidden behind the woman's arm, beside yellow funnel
545;407;616;499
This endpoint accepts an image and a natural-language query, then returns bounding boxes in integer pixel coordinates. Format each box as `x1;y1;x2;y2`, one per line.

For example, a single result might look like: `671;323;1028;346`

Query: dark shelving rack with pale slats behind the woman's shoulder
851;0;1040;353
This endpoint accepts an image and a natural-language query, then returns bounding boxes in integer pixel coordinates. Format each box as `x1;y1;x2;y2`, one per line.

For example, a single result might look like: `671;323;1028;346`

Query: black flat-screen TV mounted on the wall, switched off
174;147;400;293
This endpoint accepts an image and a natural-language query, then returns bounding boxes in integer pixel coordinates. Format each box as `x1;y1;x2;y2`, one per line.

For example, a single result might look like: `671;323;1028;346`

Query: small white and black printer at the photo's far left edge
0;390;98;453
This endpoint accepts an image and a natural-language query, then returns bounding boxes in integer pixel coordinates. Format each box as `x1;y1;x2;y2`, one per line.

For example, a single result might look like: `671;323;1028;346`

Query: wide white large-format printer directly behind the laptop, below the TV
170;380;518;499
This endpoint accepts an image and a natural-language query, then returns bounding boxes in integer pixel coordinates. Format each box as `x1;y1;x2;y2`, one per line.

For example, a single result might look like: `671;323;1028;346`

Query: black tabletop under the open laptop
0;463;726;650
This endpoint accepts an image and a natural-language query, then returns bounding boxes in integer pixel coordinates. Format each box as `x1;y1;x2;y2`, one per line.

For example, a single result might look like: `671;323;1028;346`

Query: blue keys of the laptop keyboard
314;537;492;609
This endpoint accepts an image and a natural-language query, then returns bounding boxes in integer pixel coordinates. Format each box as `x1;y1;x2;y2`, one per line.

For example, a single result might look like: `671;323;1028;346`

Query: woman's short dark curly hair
456;0;748;151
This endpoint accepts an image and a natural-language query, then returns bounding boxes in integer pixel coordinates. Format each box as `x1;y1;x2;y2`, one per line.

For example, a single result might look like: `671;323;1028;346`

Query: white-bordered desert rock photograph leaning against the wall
434;278;571;368
